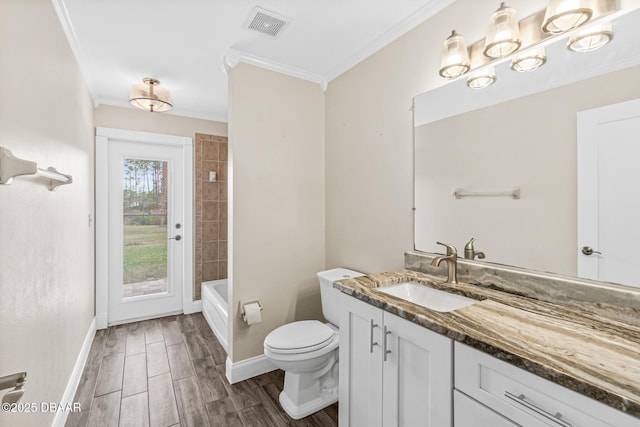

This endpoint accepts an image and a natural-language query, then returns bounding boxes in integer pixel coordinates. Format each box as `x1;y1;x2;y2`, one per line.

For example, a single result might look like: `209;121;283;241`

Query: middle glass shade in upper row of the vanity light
484;3;522;58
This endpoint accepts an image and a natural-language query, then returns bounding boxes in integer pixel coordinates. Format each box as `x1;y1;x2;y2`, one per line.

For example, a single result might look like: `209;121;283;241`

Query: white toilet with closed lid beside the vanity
264;268;363;420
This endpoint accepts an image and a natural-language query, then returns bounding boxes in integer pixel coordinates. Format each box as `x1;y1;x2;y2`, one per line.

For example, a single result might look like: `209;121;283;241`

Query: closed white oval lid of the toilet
264;320;336;353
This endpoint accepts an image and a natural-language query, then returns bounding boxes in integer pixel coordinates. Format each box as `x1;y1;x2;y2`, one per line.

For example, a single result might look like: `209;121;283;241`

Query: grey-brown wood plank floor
66;313;338;427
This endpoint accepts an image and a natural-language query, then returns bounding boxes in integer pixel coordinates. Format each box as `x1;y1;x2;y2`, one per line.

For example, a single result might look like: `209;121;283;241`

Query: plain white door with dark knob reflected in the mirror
578;99;640;286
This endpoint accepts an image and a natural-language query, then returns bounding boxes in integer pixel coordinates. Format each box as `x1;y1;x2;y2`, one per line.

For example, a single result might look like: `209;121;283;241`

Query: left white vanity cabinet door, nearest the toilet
338;294;382;427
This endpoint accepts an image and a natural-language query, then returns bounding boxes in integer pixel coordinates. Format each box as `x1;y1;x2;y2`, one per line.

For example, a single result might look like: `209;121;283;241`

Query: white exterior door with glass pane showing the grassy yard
96;129;192;327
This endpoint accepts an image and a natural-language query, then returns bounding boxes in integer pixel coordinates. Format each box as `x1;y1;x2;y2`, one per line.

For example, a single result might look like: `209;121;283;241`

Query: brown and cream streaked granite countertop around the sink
334;270;640;418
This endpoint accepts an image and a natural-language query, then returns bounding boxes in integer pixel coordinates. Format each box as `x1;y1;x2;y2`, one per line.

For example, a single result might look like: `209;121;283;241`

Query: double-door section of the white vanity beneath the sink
339;294;453;427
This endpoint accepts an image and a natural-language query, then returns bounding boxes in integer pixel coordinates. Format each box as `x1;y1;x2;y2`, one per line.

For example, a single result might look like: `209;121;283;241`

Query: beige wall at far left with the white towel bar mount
0;0;94;427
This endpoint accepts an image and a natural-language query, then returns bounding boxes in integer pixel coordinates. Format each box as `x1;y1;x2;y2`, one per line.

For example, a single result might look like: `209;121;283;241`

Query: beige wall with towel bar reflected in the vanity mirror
416;67;640;276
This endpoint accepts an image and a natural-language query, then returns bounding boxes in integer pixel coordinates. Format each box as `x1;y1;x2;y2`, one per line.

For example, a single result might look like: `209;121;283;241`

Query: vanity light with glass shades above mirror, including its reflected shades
439;0;618;89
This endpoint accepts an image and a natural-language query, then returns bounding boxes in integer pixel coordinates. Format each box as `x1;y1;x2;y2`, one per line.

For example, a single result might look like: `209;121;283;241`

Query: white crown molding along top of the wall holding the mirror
324;0;456;82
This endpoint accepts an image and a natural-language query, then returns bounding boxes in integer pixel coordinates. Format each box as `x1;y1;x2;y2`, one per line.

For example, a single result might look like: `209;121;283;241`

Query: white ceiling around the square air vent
53;0;454;122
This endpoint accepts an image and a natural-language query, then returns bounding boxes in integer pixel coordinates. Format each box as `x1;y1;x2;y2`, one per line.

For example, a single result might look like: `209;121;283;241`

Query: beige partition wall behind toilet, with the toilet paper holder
229;63;325;361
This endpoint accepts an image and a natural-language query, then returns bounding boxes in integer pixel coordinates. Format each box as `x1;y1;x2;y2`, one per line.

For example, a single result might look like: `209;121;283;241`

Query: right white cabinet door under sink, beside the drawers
382;312;453;427
